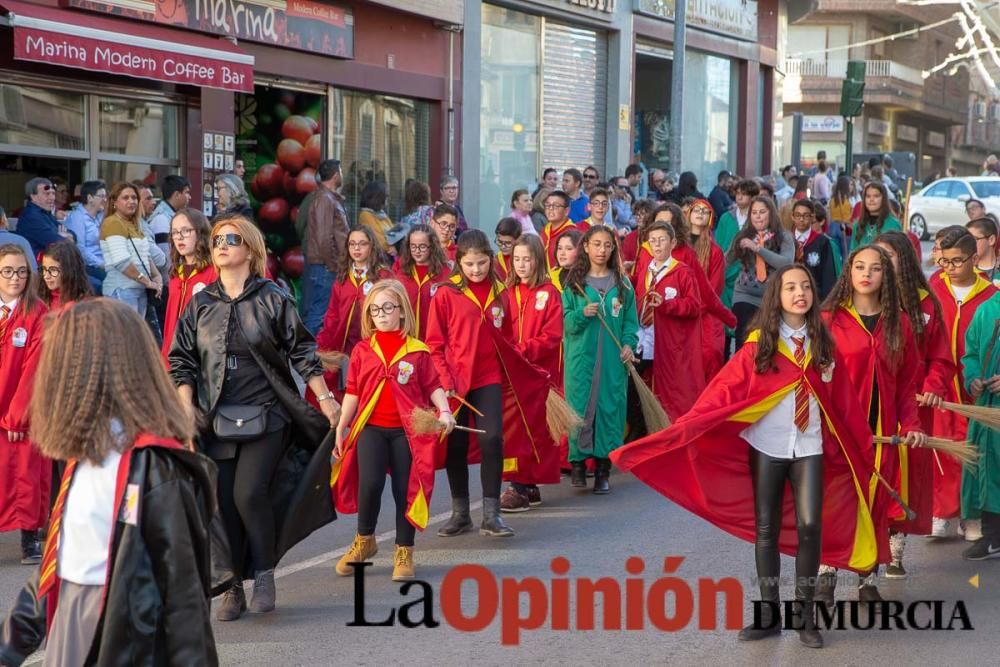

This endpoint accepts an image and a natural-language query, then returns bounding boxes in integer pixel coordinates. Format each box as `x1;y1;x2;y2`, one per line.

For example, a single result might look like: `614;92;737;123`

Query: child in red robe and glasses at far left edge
0;244;50;565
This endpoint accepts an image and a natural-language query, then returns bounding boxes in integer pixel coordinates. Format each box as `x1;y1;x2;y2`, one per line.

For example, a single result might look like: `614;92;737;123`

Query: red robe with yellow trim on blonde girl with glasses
330;336;441;530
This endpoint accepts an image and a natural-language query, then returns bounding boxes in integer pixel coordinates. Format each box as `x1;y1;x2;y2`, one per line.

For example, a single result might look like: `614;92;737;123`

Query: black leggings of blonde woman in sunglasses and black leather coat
216;426;289;577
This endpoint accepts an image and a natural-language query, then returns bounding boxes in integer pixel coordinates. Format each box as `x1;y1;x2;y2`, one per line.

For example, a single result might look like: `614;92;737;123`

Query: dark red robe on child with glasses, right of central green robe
635;260;705;421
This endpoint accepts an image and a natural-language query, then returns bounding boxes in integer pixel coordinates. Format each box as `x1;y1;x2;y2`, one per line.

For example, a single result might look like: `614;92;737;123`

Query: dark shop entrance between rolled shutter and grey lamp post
633;47;673;174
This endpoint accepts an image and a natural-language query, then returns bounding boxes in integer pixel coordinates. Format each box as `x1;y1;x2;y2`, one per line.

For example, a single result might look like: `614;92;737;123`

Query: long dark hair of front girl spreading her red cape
750;264;834;373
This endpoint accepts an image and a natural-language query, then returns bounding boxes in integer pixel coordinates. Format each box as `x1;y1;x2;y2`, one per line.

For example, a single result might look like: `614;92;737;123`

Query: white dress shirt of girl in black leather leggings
740;321;823;459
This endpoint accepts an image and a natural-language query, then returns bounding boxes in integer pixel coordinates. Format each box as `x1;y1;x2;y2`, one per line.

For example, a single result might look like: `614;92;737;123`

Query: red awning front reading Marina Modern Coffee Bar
14;25;253;93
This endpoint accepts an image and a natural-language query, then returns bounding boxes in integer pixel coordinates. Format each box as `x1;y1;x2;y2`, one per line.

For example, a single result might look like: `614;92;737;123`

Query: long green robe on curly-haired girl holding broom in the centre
563;276;639;461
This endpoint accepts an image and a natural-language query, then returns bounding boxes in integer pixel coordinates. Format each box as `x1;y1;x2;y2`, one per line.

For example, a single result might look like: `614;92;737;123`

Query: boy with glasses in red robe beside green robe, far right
930;226;997;542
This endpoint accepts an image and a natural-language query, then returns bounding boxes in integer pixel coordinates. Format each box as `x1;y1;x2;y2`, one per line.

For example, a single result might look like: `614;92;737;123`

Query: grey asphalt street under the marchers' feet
0;464;1000;667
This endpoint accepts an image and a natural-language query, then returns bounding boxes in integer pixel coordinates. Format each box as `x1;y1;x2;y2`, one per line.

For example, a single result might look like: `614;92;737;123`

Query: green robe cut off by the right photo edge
962;294;1000;519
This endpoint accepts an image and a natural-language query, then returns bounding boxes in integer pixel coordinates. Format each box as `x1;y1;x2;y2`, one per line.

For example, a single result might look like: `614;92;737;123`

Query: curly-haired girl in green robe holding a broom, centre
562;227;639;494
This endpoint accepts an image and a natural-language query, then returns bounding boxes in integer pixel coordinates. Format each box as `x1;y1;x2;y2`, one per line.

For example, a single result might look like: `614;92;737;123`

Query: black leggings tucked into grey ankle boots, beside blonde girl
445;384;503;498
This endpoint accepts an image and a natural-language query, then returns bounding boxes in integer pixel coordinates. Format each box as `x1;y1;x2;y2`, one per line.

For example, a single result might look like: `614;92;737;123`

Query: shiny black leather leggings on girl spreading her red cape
750;447;823;602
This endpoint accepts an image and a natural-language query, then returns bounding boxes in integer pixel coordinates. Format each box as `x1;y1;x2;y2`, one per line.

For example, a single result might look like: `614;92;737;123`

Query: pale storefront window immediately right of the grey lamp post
681;51;739;192
